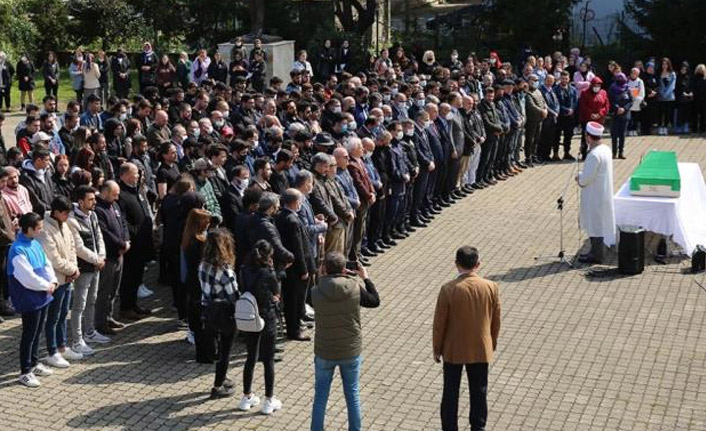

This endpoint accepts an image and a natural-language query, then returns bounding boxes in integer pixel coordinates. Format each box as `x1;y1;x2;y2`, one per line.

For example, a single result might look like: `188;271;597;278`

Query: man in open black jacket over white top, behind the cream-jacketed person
20;148;54;214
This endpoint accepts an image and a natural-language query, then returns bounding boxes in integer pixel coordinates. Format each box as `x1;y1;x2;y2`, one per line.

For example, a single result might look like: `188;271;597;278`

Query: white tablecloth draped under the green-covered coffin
614;163;706;256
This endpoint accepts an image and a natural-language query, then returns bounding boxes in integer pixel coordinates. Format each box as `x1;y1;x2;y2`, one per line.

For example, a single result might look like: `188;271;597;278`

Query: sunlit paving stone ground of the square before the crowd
0;136;706;431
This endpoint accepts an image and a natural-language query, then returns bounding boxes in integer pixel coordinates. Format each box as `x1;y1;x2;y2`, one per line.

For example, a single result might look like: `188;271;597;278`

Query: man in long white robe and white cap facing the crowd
576;121;615;263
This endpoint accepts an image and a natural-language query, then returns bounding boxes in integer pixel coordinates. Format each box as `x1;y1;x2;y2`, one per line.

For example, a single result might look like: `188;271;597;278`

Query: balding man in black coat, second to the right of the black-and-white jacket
118;163;154;320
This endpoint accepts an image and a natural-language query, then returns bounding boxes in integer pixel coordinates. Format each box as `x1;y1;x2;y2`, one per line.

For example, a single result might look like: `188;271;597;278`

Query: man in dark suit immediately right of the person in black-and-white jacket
95;181;130;334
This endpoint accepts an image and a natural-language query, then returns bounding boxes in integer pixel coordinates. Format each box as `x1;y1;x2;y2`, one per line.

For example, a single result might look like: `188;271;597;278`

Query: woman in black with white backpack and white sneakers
238;240;282;415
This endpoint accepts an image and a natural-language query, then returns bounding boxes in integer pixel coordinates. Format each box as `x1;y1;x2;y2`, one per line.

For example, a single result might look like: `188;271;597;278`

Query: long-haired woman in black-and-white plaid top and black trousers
198;228;239;399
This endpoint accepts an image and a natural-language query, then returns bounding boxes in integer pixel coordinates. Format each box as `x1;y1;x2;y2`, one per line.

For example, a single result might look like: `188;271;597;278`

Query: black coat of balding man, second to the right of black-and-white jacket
118;181;153;259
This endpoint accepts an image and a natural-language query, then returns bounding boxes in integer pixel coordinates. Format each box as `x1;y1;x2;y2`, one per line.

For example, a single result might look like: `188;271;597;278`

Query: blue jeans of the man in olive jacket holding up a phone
311;356;363;431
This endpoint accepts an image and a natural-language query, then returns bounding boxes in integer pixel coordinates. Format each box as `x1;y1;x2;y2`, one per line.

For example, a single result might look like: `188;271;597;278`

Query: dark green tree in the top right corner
621;0;706;61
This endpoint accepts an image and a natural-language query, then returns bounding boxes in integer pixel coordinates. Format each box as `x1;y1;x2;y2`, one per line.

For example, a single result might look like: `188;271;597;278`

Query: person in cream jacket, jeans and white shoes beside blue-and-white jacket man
37;196;83;368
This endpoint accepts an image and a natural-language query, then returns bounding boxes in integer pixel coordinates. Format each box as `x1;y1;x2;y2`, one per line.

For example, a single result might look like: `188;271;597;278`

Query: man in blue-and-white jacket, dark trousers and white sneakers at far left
7;213;58;388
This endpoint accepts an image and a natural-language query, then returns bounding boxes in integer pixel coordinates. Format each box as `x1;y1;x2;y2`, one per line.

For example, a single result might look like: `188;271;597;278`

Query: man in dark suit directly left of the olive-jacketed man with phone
275;189;315;341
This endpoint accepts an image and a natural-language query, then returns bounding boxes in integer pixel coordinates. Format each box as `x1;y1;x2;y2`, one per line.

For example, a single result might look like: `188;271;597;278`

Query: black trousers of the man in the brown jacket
441;362;488;431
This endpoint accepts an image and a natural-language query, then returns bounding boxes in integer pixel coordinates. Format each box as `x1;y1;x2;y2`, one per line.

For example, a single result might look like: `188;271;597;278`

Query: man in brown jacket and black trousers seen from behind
434;246;500;431
